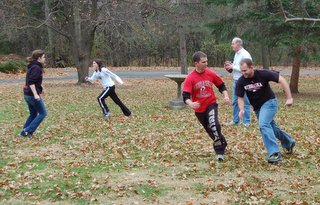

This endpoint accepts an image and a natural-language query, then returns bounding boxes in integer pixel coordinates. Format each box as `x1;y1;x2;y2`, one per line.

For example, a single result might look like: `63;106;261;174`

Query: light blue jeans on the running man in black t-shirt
255;98;294;156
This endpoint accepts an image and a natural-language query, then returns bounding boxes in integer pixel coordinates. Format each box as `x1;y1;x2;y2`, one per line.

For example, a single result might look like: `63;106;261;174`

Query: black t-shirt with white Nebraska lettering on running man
236;70;279;110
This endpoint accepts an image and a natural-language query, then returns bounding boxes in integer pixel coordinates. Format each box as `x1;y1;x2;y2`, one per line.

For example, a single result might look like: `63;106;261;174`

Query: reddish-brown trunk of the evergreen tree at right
290;46;302;93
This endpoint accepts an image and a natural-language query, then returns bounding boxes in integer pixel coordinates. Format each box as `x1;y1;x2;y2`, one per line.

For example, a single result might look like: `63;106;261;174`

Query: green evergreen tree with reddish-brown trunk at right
208;0;319;93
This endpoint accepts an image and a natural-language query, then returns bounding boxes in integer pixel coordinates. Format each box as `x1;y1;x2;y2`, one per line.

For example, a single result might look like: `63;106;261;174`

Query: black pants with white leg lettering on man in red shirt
195;103;227;154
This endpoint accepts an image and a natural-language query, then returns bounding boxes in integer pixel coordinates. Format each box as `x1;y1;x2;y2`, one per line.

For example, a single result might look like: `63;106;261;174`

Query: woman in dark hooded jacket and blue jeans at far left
20;50;47;137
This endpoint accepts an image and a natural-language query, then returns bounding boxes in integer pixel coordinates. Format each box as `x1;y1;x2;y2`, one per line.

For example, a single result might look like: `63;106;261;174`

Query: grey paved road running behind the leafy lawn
0;70;320;84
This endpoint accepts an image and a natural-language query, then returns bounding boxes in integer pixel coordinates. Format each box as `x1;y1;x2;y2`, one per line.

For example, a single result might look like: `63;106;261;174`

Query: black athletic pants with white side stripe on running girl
97;86;131;116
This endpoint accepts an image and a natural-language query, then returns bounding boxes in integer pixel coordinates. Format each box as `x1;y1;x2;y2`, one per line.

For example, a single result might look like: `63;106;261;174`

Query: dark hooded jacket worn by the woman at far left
23;60;43;96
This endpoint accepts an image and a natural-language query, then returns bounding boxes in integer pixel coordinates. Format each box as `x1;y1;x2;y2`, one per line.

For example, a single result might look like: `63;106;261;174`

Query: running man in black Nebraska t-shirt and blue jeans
236;59;296;163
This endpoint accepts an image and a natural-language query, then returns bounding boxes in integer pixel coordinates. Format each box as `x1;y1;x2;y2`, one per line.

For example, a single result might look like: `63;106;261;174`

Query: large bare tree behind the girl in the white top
3;0;149;83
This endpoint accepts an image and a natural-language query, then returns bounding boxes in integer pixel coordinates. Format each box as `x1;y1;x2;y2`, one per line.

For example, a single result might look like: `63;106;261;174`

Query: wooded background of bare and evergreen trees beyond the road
0;0;320;93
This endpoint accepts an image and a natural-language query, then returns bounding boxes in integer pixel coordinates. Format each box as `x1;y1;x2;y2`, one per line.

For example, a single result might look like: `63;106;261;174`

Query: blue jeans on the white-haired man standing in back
232;80;251;124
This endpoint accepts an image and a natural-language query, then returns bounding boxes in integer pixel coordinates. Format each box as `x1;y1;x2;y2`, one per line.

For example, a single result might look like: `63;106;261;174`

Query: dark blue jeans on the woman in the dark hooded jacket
23;95;47;135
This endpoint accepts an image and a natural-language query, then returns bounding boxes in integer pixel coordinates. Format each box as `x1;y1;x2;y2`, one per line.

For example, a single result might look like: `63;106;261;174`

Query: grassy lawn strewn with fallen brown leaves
0;73;320;205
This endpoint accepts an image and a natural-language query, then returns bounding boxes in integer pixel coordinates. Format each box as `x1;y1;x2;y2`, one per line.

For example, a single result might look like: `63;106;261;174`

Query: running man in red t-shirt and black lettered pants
182;51;230;161
